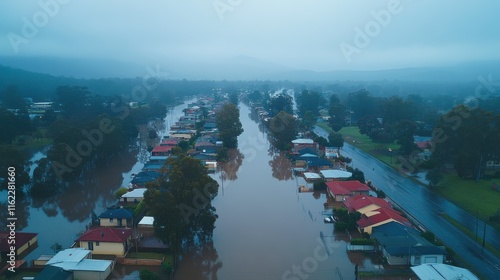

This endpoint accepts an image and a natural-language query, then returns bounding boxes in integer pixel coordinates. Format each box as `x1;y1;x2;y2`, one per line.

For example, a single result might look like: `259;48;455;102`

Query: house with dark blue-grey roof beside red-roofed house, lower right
371;222;447;265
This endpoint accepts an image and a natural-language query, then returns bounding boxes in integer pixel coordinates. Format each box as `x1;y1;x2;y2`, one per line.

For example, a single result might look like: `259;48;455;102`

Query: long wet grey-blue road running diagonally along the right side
315;127;500;279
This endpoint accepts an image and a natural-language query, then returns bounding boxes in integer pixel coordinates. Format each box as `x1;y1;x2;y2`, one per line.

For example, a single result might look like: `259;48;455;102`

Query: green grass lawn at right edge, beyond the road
433;174;500;222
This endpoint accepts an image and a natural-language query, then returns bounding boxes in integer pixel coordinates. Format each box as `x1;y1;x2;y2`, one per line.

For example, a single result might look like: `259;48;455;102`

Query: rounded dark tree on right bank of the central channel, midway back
268;111;297;150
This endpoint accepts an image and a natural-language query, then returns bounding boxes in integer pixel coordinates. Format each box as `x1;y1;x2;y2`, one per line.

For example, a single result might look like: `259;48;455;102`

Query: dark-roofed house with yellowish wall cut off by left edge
0;231;38;260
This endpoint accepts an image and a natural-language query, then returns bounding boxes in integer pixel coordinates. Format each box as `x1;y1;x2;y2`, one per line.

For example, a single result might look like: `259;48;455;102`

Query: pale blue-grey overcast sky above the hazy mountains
0;0;500;71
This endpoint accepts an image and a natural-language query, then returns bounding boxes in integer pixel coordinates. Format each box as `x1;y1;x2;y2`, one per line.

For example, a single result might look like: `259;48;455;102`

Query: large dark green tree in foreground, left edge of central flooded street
144;155;219;267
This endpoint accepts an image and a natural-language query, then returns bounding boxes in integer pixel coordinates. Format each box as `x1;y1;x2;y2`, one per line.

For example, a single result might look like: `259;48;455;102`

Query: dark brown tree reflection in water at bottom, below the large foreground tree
175;243;222;280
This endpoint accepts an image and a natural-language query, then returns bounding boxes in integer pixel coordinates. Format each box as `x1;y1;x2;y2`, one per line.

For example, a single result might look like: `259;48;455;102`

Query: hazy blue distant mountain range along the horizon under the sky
0;56;500;82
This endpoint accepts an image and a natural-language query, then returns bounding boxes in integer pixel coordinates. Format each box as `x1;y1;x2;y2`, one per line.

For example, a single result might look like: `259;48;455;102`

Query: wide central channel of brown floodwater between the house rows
175;105;362;280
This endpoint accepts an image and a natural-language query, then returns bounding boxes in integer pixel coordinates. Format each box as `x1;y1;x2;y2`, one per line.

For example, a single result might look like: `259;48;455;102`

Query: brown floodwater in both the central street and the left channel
7;100;370;280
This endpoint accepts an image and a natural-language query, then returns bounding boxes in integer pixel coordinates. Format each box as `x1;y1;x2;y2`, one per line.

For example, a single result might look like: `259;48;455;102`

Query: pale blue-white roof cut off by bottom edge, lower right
411;263;479;280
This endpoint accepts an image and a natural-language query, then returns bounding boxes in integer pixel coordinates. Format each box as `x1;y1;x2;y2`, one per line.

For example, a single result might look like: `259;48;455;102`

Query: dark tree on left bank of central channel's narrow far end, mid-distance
215;103;243;148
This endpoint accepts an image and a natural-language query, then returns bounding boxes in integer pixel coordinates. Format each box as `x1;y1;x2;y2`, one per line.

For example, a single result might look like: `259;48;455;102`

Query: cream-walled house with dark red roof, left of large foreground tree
76;227;132;256
